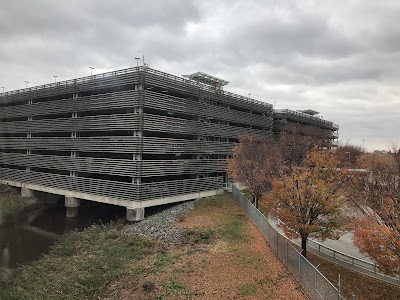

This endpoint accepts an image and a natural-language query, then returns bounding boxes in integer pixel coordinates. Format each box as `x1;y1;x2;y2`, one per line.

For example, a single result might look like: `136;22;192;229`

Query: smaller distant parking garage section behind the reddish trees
273;109;339;148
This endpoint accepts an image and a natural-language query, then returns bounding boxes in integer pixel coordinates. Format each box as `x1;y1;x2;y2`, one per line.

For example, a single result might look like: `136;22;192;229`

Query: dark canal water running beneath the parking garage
0;195;125;280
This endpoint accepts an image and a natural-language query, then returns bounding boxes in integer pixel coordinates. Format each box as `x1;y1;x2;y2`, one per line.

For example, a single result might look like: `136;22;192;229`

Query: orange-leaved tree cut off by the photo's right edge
351;145;400;274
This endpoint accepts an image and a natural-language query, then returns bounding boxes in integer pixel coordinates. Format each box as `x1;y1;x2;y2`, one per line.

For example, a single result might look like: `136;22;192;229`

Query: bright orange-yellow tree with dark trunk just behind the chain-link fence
266;147;346;257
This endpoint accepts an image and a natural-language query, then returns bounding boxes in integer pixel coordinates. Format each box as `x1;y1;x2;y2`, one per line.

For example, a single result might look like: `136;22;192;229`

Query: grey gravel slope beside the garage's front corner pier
124;200;196;245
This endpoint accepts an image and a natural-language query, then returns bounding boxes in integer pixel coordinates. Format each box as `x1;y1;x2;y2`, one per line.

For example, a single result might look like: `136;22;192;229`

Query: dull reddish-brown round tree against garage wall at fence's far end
227;135;282;207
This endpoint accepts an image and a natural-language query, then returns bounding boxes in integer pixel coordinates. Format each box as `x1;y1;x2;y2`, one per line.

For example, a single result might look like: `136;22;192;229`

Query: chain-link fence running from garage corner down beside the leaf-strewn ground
232;184;344;300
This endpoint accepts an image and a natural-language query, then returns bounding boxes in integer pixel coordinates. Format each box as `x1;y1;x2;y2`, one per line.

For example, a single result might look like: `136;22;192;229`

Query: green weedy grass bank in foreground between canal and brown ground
0;224;154;300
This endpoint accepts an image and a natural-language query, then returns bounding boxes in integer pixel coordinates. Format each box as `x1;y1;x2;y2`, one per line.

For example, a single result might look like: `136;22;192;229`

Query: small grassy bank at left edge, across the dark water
0;184;37;225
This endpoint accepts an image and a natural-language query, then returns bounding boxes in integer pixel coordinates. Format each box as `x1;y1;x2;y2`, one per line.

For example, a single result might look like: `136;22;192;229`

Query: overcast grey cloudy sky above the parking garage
0;0;400;150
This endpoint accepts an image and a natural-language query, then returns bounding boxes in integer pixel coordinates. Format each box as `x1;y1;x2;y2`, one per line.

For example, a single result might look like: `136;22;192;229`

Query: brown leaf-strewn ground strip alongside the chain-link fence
102;195;305;300
